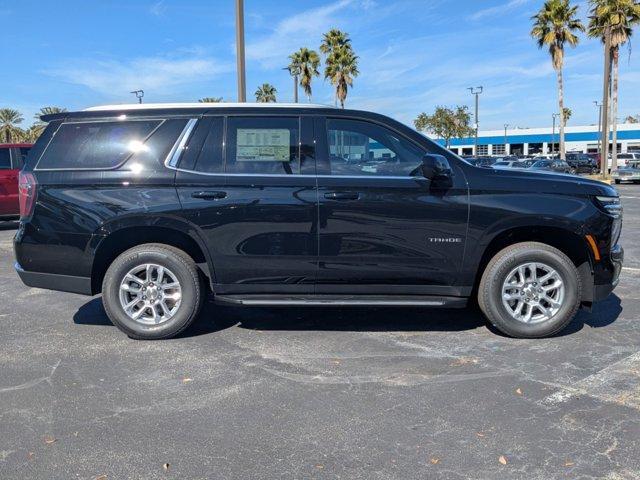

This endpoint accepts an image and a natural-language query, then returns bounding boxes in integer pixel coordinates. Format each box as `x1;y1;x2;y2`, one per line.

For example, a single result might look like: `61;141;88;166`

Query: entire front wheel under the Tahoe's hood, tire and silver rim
478;242;582;338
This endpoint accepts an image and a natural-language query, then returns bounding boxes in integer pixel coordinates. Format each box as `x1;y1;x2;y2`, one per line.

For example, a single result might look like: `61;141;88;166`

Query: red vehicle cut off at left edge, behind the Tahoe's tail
0;143;32;220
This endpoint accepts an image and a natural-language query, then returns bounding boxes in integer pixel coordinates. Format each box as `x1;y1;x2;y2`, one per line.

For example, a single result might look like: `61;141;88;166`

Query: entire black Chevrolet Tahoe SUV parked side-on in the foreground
15;104;623;339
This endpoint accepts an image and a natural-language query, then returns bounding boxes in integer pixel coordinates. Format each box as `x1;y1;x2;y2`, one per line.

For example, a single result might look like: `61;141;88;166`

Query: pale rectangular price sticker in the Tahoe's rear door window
236;128;291;162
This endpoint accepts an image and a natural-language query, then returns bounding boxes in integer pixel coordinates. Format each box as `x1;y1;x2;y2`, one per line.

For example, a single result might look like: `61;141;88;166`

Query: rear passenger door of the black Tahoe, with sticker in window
176;115;318;294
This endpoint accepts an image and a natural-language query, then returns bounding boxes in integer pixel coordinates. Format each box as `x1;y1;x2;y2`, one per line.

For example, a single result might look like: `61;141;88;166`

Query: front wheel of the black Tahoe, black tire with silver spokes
478;242;582;338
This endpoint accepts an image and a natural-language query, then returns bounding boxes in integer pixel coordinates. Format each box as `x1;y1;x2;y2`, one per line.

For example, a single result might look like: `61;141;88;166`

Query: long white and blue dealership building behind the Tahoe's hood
439;123;640;155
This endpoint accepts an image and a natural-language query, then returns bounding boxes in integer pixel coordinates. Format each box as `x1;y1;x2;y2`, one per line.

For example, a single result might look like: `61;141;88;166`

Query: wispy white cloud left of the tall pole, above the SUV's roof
45;50;233;96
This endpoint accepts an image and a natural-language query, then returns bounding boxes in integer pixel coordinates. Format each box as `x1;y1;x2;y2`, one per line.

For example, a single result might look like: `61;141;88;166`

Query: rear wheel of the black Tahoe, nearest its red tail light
102;243;205;340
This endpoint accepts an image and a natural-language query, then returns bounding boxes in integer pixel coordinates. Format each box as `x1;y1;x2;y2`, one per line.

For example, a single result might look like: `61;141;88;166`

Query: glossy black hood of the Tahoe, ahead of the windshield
480;169;618;196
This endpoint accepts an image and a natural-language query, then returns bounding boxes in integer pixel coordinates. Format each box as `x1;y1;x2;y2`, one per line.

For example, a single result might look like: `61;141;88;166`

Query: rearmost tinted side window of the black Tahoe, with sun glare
37;120;162;170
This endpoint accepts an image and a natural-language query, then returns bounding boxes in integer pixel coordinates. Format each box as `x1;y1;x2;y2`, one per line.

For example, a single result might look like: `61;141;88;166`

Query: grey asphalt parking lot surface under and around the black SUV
0;185;640;480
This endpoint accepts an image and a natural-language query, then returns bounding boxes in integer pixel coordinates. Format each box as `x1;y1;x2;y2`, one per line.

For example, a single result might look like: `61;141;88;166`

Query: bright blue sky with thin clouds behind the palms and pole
0;0;640;129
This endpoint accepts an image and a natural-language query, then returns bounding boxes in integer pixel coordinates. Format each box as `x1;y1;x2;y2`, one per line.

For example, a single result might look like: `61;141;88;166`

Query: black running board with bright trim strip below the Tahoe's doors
214;294;467;308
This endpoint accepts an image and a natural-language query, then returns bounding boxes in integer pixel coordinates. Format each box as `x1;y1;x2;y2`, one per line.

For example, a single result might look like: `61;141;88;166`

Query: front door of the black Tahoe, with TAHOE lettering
316;117;469;295
